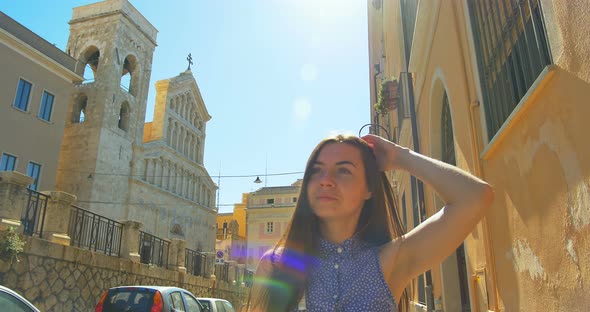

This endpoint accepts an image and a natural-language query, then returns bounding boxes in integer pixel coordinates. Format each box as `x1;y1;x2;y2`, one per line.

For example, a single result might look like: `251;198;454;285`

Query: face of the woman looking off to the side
307;143;371;220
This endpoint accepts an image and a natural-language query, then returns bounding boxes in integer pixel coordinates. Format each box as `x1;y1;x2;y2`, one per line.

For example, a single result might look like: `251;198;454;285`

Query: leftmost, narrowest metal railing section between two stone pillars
21;189;49;237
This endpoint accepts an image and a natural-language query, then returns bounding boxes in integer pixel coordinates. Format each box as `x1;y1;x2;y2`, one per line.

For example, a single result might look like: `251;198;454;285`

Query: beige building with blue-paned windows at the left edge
0;12;83;190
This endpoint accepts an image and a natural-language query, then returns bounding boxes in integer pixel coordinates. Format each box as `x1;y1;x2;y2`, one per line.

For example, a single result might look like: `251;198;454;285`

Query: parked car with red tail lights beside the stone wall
94;286;206;312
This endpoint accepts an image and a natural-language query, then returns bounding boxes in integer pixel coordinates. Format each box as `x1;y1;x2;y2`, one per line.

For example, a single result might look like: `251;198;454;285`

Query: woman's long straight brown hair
249;135;408;312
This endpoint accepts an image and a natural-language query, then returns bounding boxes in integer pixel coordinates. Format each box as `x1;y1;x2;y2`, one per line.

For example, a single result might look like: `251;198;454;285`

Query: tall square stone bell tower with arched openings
57;0;157;219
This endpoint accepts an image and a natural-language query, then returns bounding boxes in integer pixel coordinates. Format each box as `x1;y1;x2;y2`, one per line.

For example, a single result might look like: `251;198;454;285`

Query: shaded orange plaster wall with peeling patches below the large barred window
485;68;590;311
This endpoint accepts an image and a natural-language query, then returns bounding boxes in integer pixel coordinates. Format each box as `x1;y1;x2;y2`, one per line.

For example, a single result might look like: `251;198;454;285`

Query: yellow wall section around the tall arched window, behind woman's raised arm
408;1;494;311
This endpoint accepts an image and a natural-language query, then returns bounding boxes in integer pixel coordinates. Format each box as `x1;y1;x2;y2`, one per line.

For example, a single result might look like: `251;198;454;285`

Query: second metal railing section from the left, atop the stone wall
68;205;123;256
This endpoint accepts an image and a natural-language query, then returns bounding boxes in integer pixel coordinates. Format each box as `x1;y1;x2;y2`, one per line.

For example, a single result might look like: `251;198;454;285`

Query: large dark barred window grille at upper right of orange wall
468;0;552;139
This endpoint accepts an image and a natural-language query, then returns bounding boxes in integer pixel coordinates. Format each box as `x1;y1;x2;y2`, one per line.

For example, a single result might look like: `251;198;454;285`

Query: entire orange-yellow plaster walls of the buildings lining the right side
368;0;590;311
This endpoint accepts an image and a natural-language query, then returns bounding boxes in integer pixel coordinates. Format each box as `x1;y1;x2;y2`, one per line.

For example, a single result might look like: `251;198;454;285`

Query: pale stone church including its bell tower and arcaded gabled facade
0;0;217;251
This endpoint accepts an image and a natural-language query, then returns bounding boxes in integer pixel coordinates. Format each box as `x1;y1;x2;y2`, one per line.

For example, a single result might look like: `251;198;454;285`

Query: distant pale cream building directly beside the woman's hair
246;180;302;270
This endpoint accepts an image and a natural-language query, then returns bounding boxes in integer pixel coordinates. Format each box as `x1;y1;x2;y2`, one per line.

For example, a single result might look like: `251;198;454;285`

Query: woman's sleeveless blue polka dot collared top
305;235;397;312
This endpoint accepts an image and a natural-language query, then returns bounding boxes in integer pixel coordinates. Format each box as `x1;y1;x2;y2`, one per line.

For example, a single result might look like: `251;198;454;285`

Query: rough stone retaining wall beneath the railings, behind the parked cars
0;233;248;312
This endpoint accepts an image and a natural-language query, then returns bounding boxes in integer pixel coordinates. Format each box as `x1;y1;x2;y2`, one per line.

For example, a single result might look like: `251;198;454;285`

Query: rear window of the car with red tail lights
103;288;156;312
